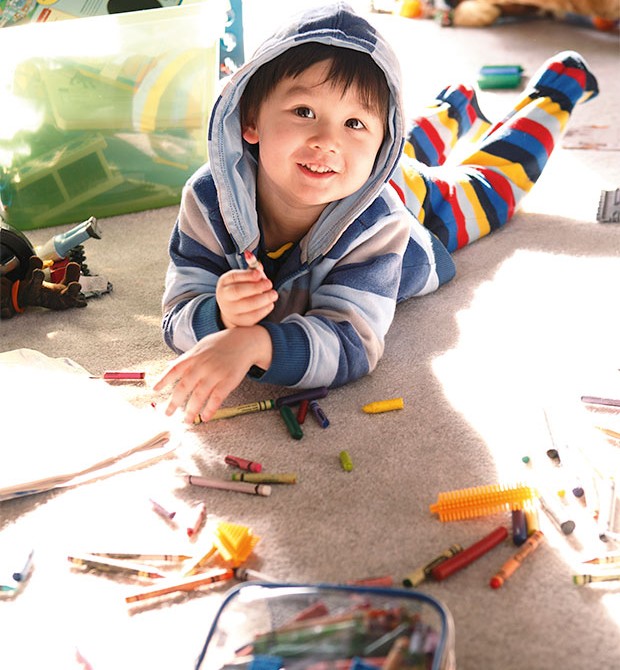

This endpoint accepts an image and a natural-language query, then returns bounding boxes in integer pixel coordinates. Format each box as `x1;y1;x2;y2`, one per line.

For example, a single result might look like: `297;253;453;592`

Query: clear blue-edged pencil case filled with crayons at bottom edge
195;582;456;670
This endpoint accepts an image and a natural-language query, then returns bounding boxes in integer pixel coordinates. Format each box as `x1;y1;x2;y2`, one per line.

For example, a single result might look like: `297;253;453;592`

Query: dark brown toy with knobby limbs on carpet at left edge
0;256;86;319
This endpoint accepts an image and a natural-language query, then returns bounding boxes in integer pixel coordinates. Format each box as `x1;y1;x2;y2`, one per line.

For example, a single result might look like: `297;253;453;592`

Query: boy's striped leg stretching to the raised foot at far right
394;51;598;251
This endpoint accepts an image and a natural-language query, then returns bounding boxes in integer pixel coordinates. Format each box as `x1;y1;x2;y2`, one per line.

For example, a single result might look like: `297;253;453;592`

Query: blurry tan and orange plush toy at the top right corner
449;0;620;31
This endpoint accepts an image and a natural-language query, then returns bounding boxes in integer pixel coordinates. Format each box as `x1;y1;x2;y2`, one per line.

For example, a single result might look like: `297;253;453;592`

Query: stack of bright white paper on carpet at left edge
0;349;176;500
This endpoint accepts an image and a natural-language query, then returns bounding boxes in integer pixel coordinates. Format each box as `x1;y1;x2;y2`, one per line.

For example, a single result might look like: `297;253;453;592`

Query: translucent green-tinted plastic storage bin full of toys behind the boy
0;0;227;230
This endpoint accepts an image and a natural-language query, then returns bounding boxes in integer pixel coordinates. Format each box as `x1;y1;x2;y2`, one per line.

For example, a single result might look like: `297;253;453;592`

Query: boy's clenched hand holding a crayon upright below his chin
215;264;278;328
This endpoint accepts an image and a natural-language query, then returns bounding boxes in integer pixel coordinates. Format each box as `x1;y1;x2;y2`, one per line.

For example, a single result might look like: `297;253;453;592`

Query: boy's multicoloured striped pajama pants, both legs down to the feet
391;51;598;252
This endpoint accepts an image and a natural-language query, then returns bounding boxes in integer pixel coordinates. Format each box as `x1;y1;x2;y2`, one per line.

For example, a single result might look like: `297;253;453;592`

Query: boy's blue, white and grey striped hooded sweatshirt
163;2;454;388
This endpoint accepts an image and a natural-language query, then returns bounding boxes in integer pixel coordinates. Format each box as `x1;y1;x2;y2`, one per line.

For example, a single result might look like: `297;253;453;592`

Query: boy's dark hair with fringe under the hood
240;42;390;127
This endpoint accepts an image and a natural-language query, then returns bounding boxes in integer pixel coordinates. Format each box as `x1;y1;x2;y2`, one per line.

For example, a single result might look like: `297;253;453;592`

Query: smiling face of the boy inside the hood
243;61;384;232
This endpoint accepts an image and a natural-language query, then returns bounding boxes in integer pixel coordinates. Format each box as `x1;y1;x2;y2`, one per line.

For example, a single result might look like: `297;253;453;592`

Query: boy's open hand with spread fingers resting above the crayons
153;326;272;423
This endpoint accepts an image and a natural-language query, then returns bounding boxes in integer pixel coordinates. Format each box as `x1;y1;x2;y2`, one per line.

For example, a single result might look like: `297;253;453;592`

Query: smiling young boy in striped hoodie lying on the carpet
154;3;597;422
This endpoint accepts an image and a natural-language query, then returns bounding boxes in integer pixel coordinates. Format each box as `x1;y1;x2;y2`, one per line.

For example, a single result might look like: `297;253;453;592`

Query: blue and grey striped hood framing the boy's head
208;2;405;262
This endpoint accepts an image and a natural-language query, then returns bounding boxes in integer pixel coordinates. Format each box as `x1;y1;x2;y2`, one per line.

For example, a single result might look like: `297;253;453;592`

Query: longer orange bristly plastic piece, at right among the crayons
430;484;538;521
